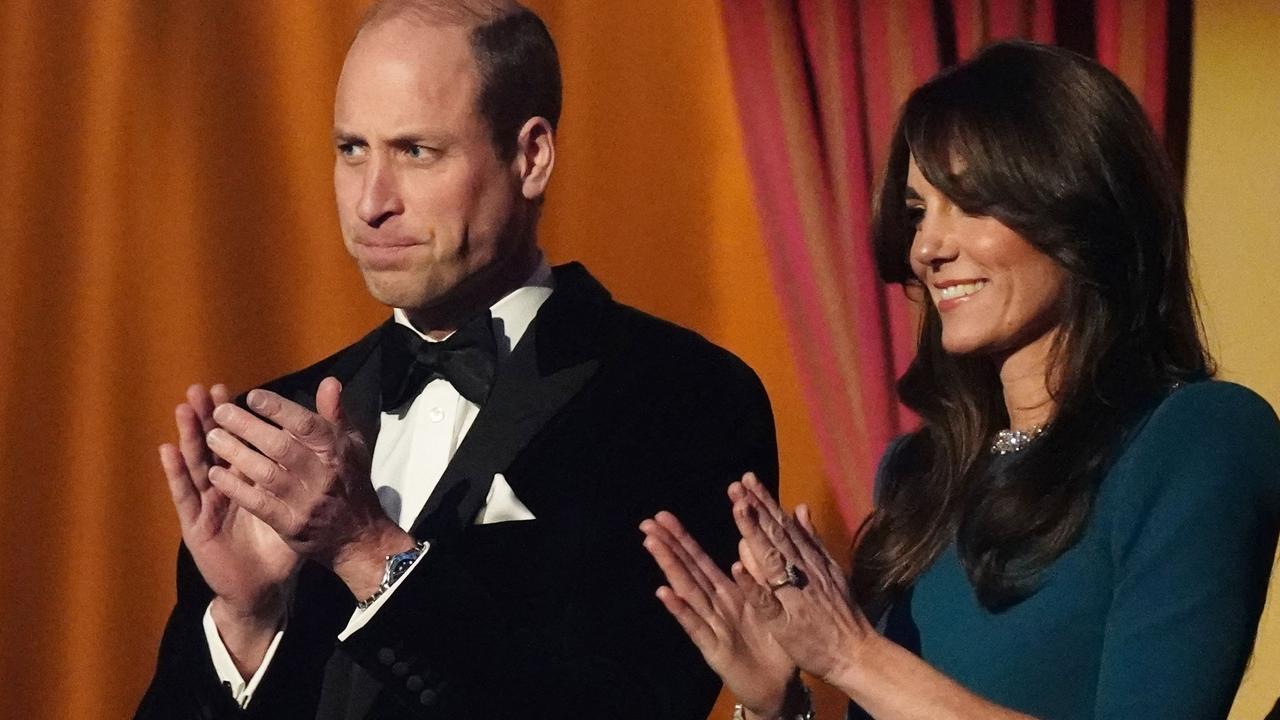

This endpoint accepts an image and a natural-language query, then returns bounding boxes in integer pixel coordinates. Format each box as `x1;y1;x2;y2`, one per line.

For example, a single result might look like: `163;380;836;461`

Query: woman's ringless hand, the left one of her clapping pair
640;507;799;717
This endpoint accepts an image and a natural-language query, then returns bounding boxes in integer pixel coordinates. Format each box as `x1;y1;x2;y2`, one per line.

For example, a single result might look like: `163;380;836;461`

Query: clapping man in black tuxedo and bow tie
138;0;777;720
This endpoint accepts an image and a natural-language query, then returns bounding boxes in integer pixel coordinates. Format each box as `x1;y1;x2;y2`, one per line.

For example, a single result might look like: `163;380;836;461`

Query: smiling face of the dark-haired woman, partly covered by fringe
906;158;1068;355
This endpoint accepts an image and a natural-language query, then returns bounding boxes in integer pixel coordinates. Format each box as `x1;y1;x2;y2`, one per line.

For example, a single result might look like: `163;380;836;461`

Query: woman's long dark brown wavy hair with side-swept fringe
852;42;1213;618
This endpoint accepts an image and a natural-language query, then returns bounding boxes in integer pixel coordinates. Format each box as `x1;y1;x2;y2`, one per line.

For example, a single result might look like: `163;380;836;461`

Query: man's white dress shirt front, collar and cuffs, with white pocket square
204;261;554;707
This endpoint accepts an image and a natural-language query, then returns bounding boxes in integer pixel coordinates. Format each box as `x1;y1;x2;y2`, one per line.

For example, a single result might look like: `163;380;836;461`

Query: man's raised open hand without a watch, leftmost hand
160;384;300;674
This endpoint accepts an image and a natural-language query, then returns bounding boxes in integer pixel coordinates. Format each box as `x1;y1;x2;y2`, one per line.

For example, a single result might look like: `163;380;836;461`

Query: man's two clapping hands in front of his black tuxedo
160;378;413;674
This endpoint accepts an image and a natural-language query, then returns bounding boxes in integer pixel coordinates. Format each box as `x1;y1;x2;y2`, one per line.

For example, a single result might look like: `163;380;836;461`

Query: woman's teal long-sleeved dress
875;382;1280;720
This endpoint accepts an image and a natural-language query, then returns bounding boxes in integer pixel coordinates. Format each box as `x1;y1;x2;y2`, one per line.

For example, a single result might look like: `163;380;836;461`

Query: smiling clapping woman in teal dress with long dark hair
641;42;1280;719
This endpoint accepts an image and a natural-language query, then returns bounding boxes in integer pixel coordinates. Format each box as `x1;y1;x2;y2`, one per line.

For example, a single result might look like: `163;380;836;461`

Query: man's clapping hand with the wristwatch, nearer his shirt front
207;378;413;598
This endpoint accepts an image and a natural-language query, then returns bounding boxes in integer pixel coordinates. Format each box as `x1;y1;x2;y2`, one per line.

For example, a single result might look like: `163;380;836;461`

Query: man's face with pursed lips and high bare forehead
333;19;531;313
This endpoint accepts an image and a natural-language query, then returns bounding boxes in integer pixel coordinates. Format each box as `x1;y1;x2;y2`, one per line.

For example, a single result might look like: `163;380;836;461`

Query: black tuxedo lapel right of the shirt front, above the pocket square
412;264;609;538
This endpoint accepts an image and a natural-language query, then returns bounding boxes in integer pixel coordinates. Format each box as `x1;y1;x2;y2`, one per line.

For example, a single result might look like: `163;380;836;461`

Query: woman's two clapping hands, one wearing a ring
640;473;876;717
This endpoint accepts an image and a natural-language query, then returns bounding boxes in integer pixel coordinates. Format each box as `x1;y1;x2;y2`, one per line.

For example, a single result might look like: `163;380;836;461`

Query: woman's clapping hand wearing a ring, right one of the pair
730;474;878;682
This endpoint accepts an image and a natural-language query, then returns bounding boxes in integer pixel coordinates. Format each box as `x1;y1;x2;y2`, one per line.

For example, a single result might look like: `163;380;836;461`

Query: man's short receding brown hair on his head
357;0;562;160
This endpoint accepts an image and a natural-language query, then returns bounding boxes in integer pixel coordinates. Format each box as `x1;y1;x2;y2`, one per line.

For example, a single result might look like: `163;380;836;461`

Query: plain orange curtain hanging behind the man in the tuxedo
0;0;824;720
